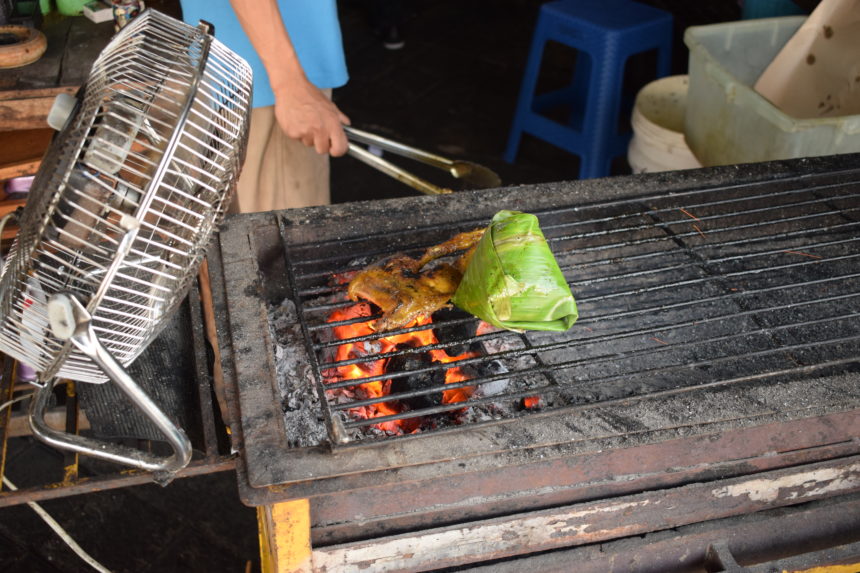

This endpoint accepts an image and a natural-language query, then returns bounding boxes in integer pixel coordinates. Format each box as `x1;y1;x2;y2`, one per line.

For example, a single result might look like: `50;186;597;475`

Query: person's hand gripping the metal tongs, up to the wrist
275;80;350;157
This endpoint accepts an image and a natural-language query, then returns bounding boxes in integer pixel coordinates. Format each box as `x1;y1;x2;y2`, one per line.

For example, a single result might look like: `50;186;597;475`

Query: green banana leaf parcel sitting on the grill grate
451;211;579;332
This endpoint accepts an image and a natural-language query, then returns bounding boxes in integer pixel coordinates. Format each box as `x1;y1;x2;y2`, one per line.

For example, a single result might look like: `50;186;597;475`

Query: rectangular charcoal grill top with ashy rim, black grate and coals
211;155;860;496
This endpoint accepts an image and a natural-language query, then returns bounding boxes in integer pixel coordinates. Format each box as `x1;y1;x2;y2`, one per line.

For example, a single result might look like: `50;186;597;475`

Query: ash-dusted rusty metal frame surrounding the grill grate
210;156;860;544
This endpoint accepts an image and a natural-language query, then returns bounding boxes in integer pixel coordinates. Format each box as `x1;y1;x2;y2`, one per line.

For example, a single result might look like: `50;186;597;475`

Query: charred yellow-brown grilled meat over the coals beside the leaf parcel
347;229;484;332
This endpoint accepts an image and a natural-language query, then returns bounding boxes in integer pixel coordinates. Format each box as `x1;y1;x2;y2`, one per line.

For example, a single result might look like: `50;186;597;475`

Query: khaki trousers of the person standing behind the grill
229;95;331;213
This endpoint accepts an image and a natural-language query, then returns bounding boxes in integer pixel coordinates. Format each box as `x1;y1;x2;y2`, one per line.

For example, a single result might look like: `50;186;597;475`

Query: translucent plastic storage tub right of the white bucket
684;16;860;165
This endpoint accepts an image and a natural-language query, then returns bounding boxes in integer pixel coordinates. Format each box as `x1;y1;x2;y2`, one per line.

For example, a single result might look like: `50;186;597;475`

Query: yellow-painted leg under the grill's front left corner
257;499;313;573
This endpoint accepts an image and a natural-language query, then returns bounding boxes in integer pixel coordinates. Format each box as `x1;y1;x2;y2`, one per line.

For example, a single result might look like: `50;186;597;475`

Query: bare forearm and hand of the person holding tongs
230;0;349;156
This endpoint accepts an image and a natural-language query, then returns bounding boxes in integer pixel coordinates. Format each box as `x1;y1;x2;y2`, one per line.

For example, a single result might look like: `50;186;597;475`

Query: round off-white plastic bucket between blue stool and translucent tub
627;75;702;173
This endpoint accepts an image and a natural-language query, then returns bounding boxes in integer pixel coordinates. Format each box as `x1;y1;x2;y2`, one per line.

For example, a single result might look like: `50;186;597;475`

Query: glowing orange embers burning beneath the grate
323;303;476;434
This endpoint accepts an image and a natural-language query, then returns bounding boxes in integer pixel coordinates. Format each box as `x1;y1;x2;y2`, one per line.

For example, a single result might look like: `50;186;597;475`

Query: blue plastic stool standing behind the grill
504;0;672;179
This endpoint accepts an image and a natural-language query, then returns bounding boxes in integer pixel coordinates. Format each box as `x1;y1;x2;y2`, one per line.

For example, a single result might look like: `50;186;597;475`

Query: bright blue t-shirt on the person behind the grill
181;0;349;107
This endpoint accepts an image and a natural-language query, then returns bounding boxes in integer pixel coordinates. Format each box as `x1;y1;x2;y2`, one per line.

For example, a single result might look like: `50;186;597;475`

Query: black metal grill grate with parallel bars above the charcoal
280;174;860;443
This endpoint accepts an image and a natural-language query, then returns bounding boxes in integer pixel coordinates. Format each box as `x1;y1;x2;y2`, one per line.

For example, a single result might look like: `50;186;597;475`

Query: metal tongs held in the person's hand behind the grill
343;126;502;195
